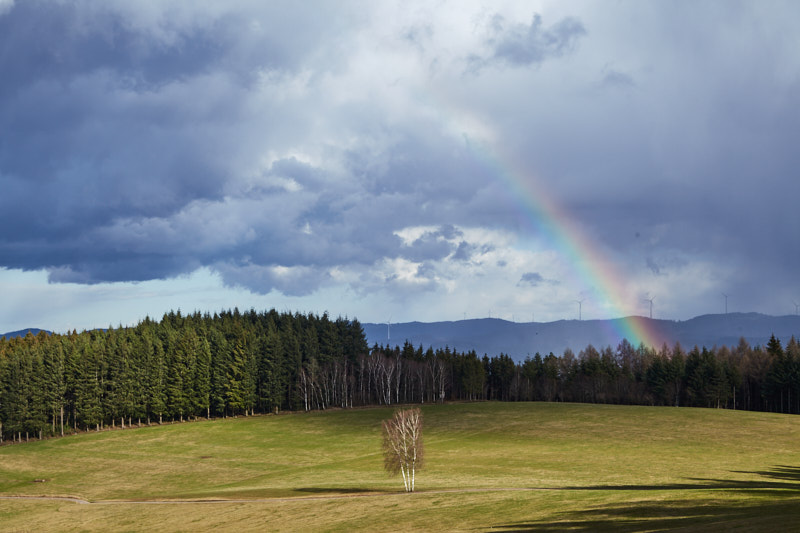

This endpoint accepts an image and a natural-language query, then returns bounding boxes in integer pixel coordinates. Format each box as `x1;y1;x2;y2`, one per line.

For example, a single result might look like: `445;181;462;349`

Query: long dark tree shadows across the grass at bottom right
492;466;800;532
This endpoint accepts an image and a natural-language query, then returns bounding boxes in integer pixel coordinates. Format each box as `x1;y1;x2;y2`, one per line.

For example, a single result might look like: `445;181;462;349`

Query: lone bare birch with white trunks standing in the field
383;408;424;492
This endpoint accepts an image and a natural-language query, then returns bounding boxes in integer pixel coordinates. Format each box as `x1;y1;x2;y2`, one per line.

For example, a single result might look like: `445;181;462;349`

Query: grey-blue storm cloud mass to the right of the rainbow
476;3;800;304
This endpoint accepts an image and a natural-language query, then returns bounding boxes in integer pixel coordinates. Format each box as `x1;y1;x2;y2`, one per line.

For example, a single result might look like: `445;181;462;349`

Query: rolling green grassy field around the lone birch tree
0;403;800;532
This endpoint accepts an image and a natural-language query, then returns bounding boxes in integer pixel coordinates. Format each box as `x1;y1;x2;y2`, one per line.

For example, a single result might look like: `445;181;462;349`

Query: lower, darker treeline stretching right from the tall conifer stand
369;336;800;414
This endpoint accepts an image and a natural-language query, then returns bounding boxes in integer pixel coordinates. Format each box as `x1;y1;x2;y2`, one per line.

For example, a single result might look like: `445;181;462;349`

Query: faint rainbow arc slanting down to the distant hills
470;143;665;349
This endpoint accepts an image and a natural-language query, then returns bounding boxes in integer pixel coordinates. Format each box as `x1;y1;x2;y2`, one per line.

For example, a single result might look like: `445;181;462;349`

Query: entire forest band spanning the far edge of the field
0;309;800;442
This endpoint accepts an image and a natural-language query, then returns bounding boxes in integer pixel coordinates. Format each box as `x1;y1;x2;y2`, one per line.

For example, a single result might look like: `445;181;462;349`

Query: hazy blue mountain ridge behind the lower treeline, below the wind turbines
362;313;800;360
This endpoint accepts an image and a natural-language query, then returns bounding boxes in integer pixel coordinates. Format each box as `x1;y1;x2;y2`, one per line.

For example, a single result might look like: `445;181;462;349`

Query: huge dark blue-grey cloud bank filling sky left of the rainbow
0;2;566;294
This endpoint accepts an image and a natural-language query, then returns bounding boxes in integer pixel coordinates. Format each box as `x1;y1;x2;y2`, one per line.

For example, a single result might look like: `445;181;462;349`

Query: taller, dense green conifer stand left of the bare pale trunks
0;310;369;440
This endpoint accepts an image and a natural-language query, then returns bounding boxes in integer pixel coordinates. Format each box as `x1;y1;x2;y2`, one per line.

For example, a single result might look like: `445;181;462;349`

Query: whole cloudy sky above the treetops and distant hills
0;0;800;332
